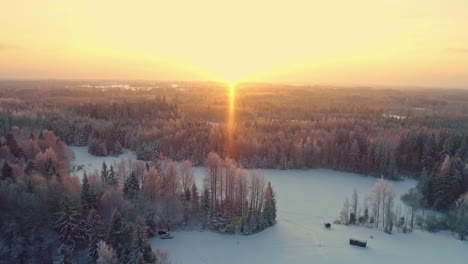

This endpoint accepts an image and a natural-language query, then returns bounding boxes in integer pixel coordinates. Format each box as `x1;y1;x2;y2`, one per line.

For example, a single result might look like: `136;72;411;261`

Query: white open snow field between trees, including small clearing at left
71;148;468;264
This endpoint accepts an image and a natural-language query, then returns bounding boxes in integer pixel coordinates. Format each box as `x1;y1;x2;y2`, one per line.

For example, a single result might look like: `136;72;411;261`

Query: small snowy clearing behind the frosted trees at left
68;147;136;178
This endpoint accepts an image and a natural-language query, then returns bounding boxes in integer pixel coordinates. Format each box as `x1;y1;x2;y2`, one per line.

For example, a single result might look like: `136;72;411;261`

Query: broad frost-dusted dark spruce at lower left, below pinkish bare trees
54;197;84;251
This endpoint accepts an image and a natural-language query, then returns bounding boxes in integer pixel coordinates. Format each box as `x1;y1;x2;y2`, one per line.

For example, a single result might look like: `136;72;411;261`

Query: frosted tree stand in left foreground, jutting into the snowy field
0;127;276;263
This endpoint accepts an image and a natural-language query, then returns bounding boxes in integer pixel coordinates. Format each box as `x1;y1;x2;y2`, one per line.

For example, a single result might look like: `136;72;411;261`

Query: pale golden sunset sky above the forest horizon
0;0;468;88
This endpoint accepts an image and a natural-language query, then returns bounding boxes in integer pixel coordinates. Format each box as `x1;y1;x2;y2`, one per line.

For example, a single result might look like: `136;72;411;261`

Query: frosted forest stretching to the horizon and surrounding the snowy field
0;81;468;263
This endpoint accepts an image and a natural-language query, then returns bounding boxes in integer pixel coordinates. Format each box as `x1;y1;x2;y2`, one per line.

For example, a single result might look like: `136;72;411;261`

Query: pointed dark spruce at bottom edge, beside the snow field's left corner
129;220;156;264
